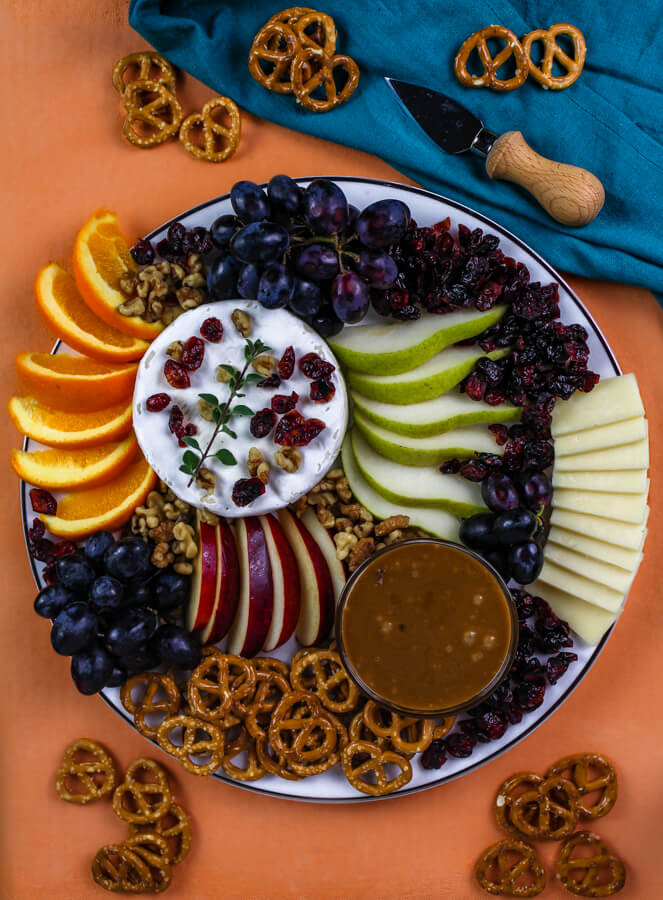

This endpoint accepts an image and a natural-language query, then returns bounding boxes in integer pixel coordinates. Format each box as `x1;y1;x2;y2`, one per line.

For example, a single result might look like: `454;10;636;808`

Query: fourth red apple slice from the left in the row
258;516;300;652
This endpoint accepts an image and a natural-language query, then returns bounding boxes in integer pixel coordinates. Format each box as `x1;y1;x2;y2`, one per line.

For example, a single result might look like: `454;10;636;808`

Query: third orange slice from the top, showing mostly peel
15;353;138;412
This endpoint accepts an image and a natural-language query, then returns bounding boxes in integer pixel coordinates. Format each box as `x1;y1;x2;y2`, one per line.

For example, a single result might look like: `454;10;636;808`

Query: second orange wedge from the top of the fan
35;263;149;362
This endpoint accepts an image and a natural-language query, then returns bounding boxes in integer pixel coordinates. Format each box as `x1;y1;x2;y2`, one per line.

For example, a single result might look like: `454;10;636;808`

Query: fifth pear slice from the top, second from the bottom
351;428;486;516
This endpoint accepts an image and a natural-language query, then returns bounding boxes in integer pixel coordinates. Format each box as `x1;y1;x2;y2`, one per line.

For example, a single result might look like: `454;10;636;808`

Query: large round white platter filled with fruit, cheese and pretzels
10;176;649;802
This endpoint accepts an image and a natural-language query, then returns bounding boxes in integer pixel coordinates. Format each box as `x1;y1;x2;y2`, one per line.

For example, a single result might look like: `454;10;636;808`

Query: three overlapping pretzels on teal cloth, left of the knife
249;6;359;112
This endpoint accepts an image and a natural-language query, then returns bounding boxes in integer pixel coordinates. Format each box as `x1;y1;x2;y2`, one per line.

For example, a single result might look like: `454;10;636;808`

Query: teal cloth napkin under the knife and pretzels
129;0;663;292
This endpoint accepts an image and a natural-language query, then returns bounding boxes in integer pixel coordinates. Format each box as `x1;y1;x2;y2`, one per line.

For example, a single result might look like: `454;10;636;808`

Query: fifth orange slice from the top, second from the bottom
9;433;138;490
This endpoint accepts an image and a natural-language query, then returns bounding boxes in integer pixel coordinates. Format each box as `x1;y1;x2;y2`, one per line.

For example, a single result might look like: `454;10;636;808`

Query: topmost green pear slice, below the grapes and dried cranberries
327;306;507;375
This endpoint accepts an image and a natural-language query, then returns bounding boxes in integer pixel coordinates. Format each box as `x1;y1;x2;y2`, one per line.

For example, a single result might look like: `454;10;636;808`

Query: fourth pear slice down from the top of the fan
354;410;503;466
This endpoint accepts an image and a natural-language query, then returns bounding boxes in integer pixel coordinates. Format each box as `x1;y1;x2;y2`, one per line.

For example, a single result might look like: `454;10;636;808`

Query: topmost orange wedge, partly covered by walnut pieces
72;209;164;341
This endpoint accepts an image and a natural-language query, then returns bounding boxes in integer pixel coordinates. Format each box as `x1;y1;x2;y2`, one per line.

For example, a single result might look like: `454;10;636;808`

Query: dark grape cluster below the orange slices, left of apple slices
34;531;202;694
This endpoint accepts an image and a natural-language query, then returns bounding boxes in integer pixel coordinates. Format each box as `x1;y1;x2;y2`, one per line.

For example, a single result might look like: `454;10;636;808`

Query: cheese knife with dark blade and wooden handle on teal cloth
385;78;605;228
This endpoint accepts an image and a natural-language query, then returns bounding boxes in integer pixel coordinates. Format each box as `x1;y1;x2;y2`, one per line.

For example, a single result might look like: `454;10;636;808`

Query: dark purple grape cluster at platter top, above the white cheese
207;175;410;337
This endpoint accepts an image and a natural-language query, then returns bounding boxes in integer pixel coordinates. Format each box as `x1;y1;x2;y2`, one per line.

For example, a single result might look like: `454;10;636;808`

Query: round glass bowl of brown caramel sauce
336;538;518;718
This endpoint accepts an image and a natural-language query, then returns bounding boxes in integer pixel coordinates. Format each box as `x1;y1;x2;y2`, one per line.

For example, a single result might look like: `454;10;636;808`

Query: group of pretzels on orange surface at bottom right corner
474;753;626;897
